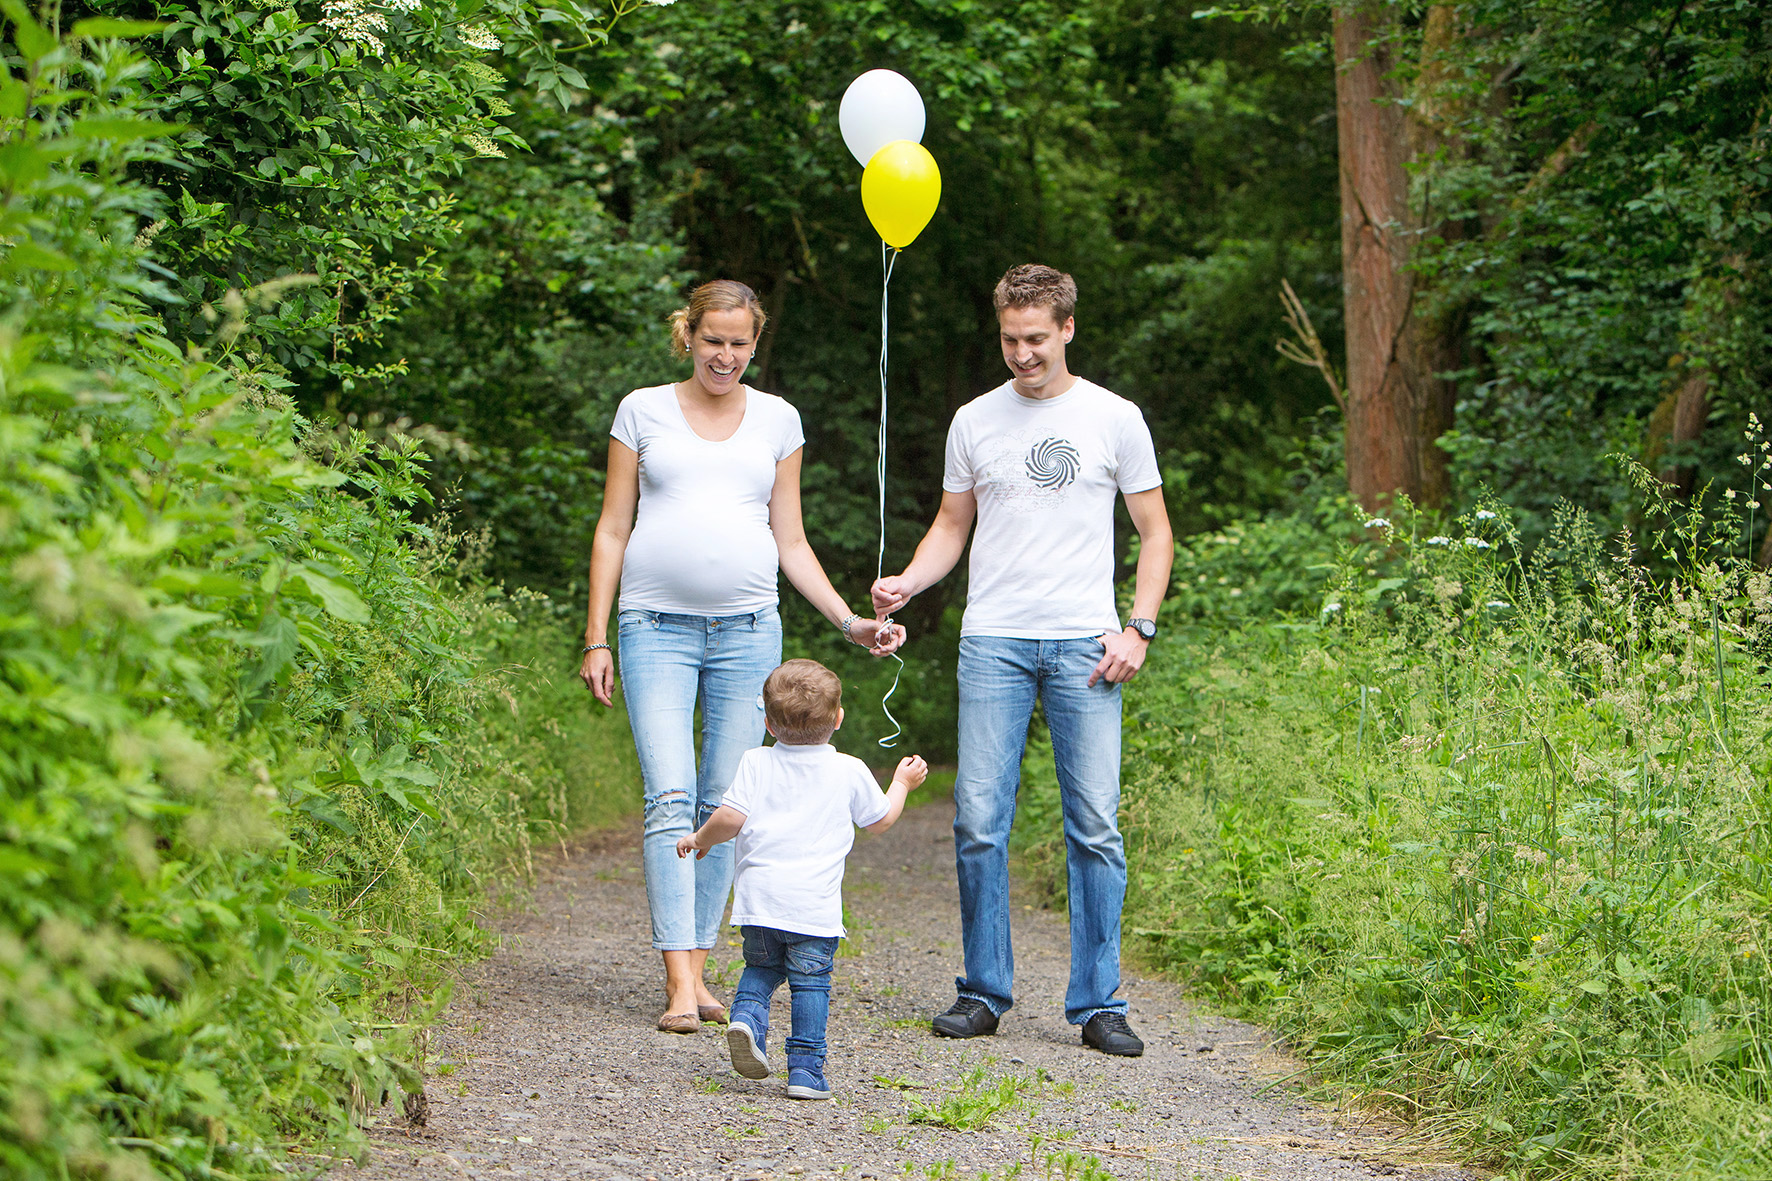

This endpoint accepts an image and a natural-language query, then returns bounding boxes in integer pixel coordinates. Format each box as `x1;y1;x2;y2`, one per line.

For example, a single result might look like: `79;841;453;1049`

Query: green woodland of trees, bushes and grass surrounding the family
0;0;1772;1177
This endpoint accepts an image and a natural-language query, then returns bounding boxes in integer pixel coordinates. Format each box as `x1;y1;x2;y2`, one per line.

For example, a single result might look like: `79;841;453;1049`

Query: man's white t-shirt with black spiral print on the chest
941;378;1162;640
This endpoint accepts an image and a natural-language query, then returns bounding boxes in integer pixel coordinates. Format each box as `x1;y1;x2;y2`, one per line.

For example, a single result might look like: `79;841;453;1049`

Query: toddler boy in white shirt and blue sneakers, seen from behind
677;660;929;1099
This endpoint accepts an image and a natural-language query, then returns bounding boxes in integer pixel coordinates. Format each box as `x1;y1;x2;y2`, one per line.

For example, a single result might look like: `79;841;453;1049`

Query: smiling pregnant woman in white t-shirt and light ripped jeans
579;280;904;1034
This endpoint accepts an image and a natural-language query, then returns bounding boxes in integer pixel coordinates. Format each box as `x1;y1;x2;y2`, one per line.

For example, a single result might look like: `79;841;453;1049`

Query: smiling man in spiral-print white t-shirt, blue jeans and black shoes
874;264;1175;1057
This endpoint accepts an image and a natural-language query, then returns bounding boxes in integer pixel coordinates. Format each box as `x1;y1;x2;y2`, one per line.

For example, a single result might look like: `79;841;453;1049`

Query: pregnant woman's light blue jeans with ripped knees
618;606;781;950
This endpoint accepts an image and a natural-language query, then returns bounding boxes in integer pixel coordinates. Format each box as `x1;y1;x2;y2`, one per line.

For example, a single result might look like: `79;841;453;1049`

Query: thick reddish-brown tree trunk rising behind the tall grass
1334;5;1460;512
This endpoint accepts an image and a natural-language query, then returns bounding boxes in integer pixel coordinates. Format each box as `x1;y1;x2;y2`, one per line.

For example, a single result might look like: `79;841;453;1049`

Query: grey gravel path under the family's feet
331;798;1480;1181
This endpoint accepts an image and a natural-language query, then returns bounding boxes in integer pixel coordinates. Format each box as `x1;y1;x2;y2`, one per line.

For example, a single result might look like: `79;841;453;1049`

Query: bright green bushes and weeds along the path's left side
0;13;637;1177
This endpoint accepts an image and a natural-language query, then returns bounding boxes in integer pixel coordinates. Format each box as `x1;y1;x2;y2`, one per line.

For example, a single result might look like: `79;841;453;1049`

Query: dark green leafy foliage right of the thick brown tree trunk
1421;0;1772;541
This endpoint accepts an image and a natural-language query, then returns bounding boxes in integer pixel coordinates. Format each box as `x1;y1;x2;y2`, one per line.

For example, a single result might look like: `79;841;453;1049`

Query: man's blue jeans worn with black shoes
953;637;1125;1025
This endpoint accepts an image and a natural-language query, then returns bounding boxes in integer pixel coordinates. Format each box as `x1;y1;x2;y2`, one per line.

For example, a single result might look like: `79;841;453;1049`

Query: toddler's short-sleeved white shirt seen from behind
721;743;890;935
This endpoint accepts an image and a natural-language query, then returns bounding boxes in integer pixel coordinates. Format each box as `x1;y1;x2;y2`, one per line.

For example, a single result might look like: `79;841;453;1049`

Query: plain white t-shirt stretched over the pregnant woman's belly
610;385;806;615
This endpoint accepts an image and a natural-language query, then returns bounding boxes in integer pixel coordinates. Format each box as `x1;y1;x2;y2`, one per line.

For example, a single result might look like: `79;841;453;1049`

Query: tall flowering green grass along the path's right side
1030;445;1772;1177
